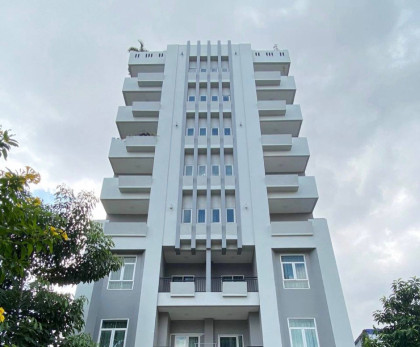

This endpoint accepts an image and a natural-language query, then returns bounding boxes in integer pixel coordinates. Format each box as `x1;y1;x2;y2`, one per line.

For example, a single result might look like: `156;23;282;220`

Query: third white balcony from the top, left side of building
116;102;160;139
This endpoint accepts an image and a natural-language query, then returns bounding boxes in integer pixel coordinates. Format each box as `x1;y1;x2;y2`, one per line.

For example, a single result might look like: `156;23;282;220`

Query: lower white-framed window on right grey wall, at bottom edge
288;318;319;347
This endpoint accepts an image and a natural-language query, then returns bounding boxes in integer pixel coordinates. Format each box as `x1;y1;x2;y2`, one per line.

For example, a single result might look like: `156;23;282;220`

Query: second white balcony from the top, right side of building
256;76;296;104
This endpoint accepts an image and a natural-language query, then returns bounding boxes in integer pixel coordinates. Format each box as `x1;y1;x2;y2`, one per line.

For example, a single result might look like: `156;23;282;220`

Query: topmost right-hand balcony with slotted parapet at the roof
253;50;290;76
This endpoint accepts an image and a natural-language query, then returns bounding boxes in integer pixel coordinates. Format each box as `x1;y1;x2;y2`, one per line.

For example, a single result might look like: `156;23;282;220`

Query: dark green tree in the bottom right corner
373;277;420;347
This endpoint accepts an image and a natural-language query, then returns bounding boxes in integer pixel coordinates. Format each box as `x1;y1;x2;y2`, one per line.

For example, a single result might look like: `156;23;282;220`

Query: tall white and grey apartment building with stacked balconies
78;42;353;347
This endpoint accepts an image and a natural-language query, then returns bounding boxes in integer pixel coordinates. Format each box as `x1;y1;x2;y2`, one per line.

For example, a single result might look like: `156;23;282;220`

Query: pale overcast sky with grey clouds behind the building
0;0;420;337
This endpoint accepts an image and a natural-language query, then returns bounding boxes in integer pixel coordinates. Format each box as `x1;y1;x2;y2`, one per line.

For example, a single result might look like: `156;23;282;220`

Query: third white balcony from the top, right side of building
258;100;303;137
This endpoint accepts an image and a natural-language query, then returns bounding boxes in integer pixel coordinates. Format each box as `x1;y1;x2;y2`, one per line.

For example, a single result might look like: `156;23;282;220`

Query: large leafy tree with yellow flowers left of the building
0;129;121;347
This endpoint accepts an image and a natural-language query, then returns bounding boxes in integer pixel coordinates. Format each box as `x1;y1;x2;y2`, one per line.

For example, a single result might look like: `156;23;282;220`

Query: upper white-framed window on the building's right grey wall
281;255;309;289
